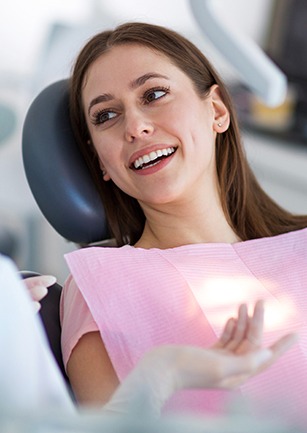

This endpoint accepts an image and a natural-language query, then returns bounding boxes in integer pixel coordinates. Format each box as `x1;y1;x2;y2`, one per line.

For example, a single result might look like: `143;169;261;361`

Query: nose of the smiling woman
125;109;154;143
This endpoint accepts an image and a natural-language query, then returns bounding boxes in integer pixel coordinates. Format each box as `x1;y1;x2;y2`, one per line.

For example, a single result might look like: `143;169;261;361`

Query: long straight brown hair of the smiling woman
70;23;307;245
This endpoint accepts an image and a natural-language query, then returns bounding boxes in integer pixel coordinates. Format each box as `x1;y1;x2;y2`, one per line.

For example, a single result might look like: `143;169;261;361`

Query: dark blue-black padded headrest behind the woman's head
22;80;109;244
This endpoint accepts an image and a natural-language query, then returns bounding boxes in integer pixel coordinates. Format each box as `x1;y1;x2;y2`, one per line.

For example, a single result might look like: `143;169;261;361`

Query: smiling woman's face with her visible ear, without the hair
82;44;229;205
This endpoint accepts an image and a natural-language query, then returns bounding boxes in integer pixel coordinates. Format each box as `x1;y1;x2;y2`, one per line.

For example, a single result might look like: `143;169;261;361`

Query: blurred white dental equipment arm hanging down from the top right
189;0;287;107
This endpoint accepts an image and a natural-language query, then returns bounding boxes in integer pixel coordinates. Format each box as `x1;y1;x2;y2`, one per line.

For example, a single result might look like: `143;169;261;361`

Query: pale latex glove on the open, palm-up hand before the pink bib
104;301;297;416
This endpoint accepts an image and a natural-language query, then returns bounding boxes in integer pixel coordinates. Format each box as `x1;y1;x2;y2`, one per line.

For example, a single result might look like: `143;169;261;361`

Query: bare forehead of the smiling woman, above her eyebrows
83;44;184;93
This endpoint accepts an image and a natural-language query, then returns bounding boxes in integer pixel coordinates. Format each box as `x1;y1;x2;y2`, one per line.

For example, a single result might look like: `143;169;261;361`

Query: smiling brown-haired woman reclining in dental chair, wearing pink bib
62;23;307;424
